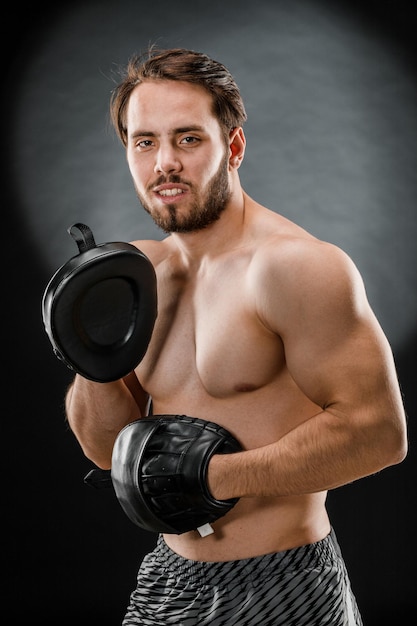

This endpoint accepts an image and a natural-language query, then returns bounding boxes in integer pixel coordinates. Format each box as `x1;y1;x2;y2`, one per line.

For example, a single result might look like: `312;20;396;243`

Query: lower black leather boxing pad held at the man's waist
109;415;242;534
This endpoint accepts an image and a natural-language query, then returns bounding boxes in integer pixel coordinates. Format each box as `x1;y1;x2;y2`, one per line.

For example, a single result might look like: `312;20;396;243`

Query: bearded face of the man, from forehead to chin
127;80;230;232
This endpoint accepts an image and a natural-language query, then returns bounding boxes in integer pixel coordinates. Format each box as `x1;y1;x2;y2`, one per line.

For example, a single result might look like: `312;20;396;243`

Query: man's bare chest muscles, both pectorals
140;276;284;398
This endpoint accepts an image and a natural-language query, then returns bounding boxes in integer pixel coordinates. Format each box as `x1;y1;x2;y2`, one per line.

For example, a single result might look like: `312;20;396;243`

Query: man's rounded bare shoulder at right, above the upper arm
250;214;368;328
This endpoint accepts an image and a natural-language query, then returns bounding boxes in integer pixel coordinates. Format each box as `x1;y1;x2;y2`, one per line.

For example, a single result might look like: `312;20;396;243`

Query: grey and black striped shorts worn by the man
123;530;362;626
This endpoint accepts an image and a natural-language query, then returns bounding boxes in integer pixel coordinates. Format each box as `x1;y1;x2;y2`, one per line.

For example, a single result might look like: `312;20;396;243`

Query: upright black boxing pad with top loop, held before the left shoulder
42;223;157;382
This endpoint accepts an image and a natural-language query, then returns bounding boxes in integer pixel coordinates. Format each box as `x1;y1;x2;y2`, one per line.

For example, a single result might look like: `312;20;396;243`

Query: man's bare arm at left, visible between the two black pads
65;372;148;469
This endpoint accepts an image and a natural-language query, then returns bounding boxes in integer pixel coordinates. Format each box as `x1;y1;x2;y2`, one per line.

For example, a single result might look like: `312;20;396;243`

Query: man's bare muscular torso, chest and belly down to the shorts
133;202;329;561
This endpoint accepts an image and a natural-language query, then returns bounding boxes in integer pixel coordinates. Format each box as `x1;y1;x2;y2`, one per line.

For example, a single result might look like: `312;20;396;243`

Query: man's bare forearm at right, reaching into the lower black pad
208;402;404;500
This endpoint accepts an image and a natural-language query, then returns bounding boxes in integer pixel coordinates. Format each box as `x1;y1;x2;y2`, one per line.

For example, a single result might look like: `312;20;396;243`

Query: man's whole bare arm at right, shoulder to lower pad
207;244;407;499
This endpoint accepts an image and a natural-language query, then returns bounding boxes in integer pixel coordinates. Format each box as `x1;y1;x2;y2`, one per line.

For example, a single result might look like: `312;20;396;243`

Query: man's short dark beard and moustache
136;153;231;233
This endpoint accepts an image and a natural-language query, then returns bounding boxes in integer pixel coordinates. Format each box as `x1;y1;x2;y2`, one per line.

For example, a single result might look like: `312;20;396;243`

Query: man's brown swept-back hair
110;47;247;146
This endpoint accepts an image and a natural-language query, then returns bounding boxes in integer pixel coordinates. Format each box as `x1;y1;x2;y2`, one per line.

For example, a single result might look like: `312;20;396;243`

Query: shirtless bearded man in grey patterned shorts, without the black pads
66;50;407;626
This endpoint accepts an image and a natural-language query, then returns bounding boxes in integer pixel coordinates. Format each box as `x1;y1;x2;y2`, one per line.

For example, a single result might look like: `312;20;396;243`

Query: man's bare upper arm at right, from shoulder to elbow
264;246;392;414
